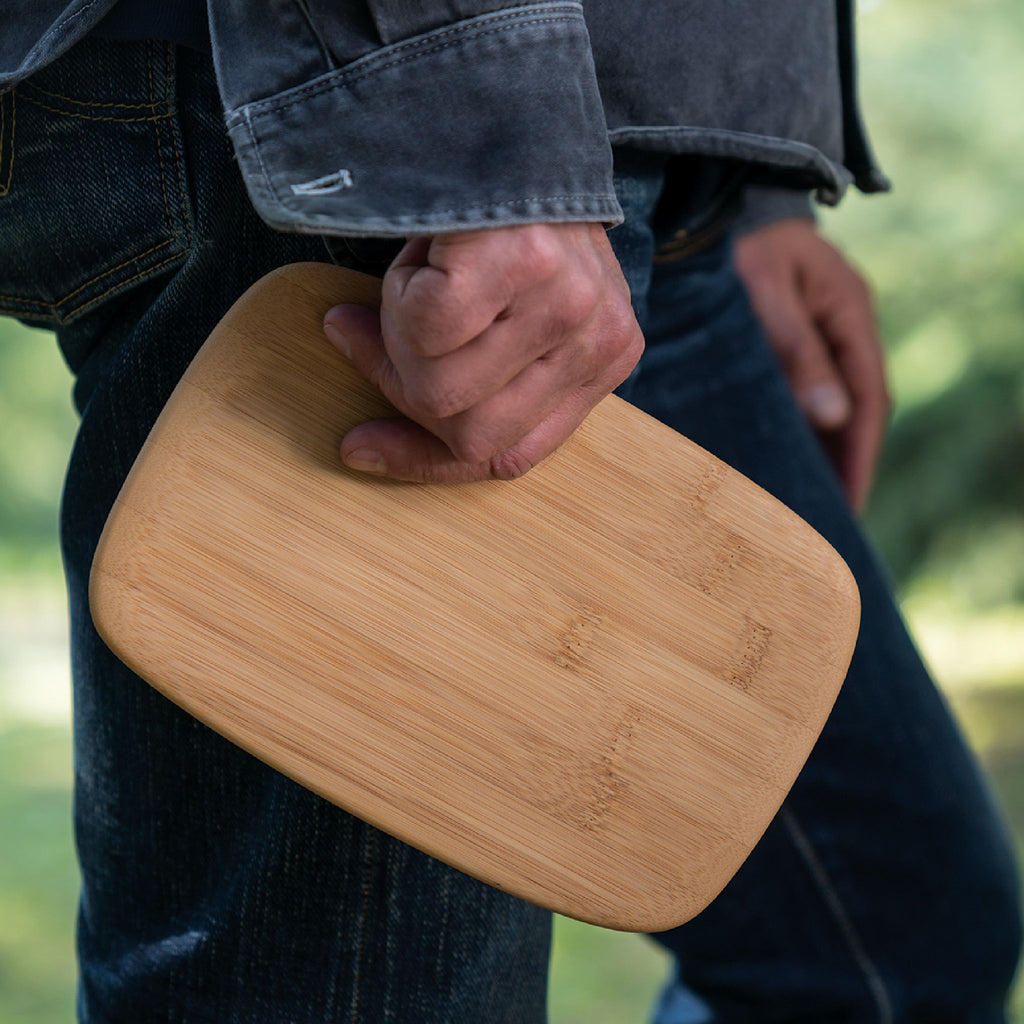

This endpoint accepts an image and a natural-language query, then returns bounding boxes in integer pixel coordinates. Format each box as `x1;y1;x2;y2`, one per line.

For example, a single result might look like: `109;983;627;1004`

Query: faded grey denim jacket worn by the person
0;0;886;237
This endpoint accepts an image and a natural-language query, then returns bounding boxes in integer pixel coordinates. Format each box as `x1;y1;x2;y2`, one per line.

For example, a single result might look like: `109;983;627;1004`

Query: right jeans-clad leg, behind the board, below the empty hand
626;237;1019;1022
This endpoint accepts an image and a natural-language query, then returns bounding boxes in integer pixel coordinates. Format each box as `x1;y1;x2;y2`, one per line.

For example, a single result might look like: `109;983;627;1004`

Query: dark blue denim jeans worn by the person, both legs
0;41;1019;1024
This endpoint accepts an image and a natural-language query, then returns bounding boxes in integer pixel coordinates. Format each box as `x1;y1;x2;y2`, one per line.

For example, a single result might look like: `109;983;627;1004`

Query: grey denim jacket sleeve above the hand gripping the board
210;0;622;237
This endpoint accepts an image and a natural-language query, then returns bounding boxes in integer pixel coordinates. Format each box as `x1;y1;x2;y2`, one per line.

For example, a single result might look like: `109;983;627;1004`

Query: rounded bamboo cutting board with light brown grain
91;264;859;931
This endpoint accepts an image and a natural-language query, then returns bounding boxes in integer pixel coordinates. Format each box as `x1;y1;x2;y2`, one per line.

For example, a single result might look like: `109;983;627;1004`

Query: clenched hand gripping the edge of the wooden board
325;223;643;483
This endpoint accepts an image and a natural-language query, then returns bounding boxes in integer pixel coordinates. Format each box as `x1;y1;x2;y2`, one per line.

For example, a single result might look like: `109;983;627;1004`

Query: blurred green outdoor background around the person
0;0;1024;1024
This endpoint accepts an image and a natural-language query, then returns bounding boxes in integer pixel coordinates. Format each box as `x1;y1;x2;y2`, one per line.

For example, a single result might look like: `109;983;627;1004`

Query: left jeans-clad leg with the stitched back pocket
0;36;550;1024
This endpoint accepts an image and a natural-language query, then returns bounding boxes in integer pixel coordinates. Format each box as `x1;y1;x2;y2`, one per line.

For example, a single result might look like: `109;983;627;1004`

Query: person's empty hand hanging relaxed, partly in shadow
735;219;890;511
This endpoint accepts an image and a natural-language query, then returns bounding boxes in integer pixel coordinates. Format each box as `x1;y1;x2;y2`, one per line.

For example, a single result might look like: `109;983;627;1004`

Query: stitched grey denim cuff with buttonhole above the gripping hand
226;3;622;237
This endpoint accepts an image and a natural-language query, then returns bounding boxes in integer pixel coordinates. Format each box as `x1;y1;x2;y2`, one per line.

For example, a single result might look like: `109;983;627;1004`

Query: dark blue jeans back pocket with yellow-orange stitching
0;39;191;327
